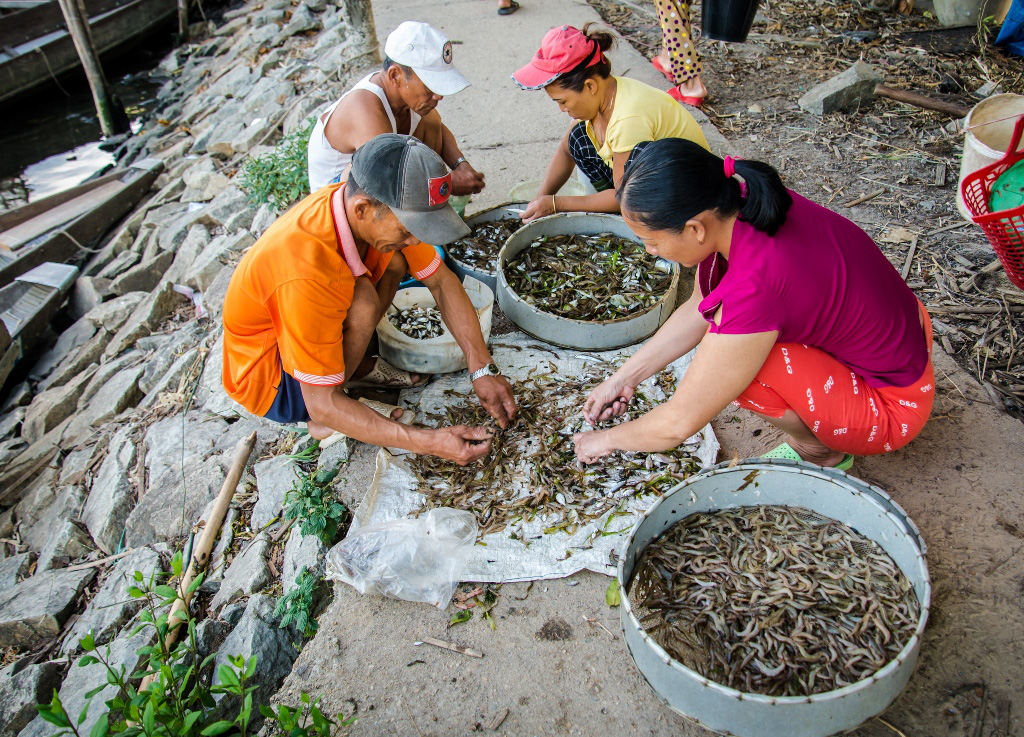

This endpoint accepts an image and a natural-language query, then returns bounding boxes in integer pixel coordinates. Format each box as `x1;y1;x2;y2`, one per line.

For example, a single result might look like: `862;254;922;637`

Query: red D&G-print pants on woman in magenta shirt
735;306;935;456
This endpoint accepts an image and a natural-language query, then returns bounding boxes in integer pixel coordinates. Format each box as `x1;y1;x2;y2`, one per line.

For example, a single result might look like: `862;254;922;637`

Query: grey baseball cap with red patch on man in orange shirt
351;133;470;246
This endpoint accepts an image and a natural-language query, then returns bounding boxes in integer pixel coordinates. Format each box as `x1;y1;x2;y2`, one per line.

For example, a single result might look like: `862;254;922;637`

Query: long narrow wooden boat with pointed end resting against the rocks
0;159;164;287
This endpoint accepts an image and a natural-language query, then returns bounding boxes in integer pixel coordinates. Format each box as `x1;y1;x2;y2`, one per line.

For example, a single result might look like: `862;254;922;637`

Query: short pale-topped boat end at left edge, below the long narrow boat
0;263;78;386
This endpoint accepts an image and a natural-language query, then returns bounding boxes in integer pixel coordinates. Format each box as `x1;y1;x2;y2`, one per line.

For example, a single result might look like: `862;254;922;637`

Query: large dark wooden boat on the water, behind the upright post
0;0;177;101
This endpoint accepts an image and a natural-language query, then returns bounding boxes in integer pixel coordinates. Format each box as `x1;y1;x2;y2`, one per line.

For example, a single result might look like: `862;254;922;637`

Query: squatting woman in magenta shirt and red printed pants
574;139;935;469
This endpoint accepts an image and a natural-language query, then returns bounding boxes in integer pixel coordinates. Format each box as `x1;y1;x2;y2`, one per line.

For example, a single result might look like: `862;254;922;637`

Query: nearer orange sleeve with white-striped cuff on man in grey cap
266;279;352;386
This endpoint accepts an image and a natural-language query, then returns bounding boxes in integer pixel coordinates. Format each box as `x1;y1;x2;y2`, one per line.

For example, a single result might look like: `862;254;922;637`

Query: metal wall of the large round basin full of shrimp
618;459;932;737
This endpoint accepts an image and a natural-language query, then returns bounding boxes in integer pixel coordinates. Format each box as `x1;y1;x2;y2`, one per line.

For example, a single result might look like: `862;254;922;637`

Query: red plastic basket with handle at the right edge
961;113;1024;290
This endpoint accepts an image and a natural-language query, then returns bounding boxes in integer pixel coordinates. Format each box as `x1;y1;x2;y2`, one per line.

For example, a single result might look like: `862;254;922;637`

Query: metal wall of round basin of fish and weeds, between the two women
496;213;679;350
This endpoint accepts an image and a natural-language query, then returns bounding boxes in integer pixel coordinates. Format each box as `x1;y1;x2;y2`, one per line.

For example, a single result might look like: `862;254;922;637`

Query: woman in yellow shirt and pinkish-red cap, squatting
512;24;708;222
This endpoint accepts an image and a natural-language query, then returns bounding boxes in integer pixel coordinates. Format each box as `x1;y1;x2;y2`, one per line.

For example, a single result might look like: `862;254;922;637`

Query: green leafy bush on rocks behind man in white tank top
238;116;316;210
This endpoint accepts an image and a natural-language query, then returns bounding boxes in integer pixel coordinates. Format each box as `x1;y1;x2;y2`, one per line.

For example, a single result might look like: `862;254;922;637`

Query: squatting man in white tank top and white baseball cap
308;20;484;194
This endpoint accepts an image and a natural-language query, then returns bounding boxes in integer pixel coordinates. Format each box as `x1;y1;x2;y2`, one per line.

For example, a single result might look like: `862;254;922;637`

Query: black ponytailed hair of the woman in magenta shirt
617;138;793;235
